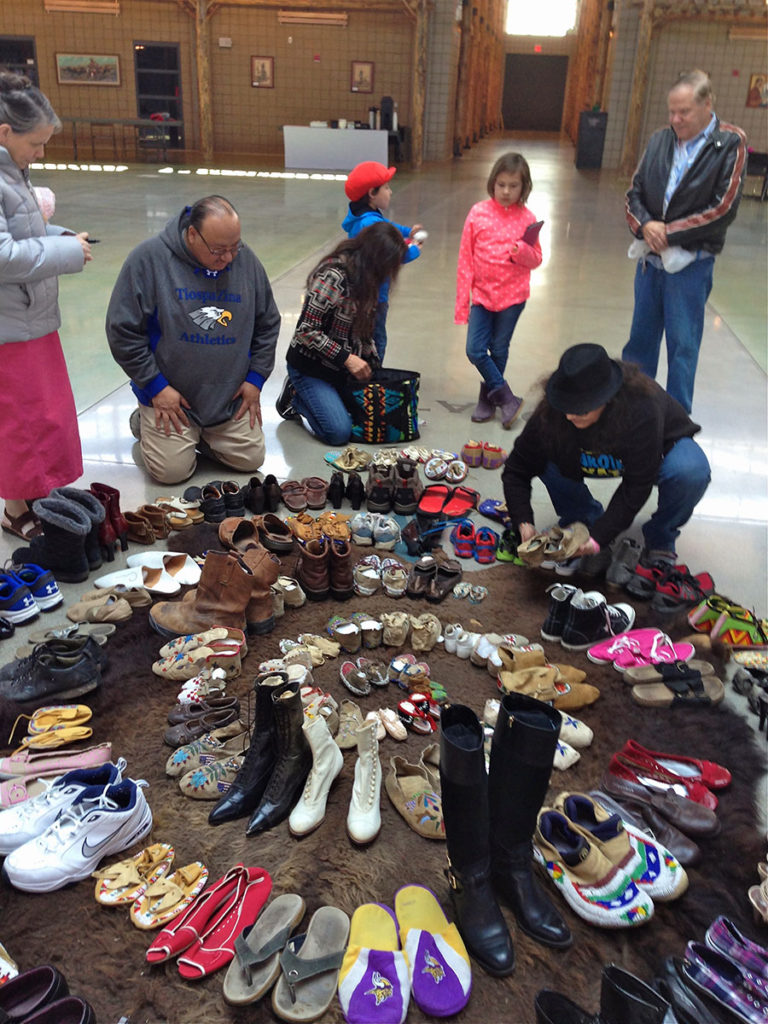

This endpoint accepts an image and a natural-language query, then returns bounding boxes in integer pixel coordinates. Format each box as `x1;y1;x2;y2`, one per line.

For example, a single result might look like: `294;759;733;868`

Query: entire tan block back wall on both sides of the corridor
0;0;768;167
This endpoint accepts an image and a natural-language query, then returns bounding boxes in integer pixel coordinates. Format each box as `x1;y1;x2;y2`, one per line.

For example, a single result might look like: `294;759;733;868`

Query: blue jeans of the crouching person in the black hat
542;437;710;551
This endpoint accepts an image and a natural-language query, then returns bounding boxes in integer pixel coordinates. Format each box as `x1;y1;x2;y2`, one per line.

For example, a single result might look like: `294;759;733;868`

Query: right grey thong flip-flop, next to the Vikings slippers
272;906;349;1021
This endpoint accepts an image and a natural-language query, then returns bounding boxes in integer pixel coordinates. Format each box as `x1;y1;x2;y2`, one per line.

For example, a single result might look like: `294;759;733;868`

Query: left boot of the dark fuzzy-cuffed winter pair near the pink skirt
11;498;91;583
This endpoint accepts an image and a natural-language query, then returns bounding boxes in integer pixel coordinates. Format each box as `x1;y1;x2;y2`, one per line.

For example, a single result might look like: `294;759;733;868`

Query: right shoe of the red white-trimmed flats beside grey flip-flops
178;867;272;981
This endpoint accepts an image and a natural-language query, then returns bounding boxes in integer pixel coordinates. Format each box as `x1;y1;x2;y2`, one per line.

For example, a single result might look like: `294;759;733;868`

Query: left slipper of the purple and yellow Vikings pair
339;903;411;1024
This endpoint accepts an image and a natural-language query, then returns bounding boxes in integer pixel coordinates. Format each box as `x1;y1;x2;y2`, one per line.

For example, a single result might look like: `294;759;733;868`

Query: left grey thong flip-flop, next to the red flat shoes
222;893;306;1007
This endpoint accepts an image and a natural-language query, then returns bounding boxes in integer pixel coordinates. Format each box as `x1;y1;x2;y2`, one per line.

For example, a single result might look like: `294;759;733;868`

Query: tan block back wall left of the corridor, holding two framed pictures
0;0;414;154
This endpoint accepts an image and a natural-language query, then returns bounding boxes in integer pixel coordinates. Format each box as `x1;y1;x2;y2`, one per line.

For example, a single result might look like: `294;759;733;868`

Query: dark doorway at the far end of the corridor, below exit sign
502;53;568;131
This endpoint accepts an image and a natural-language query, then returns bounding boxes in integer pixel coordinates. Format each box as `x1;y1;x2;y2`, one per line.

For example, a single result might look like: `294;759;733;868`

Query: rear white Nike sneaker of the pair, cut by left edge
0;758;126;856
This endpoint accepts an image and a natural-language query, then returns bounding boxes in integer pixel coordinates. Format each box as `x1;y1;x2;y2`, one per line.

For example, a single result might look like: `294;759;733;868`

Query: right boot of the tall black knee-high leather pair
488;693;572;949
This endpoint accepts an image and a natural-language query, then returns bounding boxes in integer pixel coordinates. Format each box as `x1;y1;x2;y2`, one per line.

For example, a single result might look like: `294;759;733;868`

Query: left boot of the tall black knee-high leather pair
440;705;515;977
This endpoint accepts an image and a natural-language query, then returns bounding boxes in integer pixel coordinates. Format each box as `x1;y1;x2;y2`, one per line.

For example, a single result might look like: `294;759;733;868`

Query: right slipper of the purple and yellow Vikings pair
394;886;472;1017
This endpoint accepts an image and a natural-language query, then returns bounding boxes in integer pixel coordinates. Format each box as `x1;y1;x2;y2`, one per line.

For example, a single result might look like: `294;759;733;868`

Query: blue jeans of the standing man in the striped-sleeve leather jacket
622;258;715;413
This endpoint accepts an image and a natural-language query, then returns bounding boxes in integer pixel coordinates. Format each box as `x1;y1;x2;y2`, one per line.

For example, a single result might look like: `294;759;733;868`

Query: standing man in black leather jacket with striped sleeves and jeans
622;71;746;413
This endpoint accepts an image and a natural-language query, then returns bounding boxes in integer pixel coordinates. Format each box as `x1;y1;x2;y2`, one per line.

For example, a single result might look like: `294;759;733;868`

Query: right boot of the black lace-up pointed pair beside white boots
246;682;312;836
